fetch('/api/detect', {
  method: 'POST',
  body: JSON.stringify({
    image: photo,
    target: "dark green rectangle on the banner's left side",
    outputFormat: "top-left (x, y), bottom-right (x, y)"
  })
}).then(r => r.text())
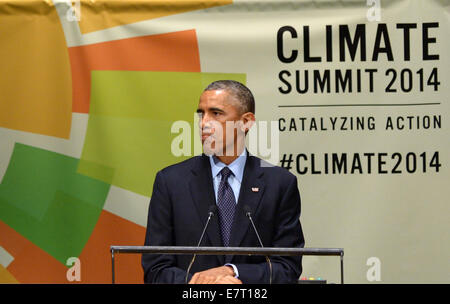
top-left (0, 143), bottom-right (110, 264)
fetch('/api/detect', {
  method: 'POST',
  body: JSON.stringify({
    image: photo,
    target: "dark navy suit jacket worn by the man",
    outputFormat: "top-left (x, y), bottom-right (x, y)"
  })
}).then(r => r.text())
top-left (142, 155), bottom-right (304, 283)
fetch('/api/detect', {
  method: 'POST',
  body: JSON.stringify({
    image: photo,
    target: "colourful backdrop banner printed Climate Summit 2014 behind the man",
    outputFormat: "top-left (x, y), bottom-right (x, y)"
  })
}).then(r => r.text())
top-left (0, 0), bottom-right (450, 283)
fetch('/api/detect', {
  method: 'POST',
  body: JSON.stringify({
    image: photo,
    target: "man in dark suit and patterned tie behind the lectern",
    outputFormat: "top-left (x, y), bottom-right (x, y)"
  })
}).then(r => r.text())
top-left (142, 80), bottom-right (304, 284)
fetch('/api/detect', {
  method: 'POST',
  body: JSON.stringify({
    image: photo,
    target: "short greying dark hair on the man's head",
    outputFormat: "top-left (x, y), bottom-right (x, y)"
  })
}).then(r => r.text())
top-left (204, 80), bottom-right (255, 114)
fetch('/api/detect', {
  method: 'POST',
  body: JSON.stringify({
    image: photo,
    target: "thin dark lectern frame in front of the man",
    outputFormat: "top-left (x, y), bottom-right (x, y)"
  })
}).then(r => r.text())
top-left (110, 246), bottom-right (344, 284)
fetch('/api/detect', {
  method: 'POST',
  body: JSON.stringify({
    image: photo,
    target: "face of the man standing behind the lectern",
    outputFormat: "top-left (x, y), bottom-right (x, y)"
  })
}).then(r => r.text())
top-left (197, 90), bottom-right (245, 156)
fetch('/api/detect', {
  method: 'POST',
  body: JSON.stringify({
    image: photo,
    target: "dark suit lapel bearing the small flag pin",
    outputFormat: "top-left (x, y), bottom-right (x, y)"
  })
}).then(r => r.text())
top-left (227, 155), bottom-right (265, 252)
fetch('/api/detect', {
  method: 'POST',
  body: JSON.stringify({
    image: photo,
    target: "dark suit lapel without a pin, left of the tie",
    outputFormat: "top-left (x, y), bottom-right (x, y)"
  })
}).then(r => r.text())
top-left (189, 155), bottom-right (224, 264)
